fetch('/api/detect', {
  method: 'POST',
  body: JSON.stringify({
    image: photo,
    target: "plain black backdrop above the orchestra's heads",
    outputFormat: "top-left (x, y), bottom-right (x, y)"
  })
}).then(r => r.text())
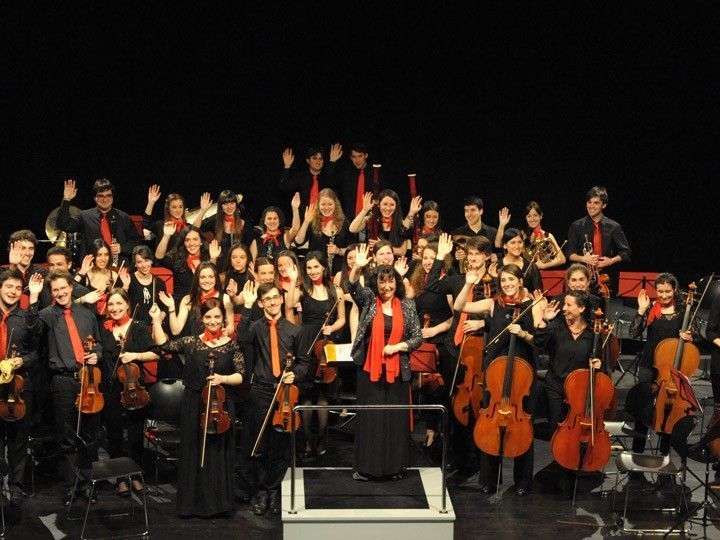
top-left (0, 2), bottom-right (720, 283)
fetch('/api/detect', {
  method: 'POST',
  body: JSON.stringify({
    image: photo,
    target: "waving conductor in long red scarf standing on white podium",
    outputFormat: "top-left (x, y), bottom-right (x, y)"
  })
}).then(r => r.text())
top-left (350, 245), bottom-right (422, 480)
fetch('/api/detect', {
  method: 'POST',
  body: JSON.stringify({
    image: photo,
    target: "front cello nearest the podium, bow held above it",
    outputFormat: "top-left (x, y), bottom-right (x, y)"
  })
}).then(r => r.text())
top-left (473, 307), bottom-right (534, 458)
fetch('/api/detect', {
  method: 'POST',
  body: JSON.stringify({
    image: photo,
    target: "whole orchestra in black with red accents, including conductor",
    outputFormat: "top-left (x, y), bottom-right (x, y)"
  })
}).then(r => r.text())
top-left (0, 143), bottom-right (720, 516)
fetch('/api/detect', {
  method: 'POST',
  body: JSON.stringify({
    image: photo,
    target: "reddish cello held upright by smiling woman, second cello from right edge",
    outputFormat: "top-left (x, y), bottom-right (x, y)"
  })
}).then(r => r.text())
top-left (550, 309), bottom-right (615, 471)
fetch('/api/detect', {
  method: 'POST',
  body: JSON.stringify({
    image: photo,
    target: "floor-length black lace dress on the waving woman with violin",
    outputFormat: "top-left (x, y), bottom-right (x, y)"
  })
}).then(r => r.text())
top-left (162, 336), bottom-right (245, 516)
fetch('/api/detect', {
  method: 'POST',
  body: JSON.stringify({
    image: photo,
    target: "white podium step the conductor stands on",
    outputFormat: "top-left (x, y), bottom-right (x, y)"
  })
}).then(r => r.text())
top-left (282, 468), bottom-right (455, 540)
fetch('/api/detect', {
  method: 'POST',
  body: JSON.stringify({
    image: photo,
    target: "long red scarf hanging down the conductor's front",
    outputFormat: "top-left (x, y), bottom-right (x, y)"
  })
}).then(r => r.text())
top-left (363, 296), bottom-right (404, 383)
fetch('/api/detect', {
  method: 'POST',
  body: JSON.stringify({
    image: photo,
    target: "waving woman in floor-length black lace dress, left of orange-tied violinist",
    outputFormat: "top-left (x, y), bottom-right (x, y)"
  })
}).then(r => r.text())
top-left (150, 298), bottom-right (245, 517)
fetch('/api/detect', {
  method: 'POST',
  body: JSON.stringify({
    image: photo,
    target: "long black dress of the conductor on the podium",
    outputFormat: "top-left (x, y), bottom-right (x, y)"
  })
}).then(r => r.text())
top-left (354, 314), bottom-right (410, 477)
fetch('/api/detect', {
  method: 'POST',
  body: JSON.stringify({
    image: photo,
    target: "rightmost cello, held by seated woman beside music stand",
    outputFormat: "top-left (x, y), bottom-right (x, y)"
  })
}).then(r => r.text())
top-left (652, 283), bottom-right (700, 435)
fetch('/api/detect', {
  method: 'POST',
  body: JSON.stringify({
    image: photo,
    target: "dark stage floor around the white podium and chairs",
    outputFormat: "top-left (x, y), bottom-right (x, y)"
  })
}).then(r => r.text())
top-left (5, 364), bottom-right (720, 540)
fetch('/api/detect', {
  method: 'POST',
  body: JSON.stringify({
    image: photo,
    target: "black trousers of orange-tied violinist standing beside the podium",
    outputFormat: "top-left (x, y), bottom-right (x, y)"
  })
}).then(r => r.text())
top-left (238, 384), bottom-right (297, 496)
